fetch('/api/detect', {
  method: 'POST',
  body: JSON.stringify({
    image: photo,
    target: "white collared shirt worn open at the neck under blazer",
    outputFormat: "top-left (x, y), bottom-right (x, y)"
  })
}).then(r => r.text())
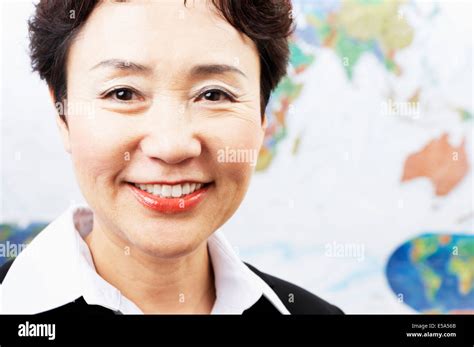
top-left (0, 205), bottom-right (289, 314)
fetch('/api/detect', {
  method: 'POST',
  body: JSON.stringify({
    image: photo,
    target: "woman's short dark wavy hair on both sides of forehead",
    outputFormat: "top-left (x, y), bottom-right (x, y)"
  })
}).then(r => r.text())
top-left (28, 0), bottom-right (294, 117)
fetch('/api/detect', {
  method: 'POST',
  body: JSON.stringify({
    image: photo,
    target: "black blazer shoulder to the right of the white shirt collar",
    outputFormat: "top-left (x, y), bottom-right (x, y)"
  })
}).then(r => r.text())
top-left (245, 263), bottom-right (344, 314)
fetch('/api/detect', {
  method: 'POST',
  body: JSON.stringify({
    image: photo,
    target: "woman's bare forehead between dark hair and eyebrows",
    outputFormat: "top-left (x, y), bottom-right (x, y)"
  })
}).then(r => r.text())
top-left (70, 0), bottom-right (258, 78)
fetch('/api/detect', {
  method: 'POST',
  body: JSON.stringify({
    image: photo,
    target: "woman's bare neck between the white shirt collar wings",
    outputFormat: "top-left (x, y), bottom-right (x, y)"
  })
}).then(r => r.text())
top-left (86, 220), bottom-right (215, 314)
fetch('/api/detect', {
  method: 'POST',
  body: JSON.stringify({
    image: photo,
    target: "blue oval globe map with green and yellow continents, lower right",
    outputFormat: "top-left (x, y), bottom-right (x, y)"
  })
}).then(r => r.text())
top-left (387, 234), bottom-right (474, 314)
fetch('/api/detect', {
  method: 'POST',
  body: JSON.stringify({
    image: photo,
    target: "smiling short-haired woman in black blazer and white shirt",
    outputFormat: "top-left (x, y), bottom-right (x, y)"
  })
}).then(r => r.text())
top-left (2, 0), bottom-right (342, 314)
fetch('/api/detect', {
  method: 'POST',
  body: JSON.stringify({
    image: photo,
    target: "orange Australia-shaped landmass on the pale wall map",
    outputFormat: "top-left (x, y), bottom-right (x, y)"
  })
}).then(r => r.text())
top-left (402, 134), bottom-right (469, 195)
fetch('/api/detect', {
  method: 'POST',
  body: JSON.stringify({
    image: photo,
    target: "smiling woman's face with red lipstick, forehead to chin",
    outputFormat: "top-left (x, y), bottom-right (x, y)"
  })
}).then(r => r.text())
top-left (59, 0), bottom-right (265, 257)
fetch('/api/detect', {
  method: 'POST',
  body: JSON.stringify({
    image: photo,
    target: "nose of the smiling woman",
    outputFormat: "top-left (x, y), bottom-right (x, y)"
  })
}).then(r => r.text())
top-left (140, 101), bottom-right (201, 164)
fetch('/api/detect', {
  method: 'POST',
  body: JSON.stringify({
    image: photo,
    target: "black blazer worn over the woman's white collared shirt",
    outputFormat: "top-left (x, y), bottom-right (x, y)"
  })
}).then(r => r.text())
top-left (0, 260), bottom-right (344, 315)
